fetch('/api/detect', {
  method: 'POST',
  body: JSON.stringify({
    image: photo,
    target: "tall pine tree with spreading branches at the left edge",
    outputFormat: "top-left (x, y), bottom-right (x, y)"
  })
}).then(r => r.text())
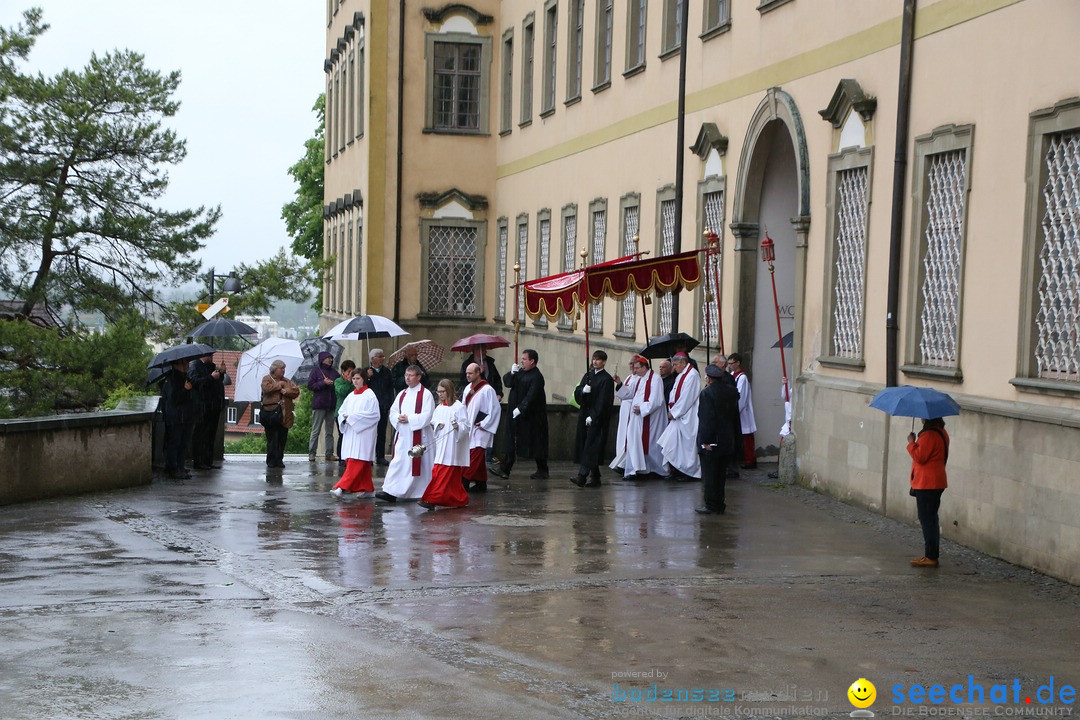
top-left (0, 9), bottom-right (220, 320)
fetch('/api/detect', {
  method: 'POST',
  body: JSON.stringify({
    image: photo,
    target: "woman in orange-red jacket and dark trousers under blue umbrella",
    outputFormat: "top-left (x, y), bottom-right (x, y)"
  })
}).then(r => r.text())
top-left (907, 418), bottom-right (948, 568)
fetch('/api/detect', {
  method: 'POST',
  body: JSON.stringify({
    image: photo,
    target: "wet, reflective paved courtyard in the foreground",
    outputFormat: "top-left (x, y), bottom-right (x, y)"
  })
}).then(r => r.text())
top-left (0, 457), bottom-right (1080, 718)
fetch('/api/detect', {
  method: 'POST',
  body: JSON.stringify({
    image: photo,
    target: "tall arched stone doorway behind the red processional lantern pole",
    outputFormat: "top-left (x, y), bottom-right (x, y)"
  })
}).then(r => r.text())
top-left (731, 87), bottom-right (810, 457)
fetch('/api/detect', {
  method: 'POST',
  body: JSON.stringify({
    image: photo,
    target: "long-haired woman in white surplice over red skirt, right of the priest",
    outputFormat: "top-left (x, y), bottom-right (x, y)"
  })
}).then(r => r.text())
top-left (419, 379), bottom-right (469, 510)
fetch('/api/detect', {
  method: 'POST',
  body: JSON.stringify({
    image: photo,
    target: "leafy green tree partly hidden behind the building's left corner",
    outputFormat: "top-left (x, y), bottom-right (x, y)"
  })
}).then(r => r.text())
top-left (281, 95), bottom-right (327, 310)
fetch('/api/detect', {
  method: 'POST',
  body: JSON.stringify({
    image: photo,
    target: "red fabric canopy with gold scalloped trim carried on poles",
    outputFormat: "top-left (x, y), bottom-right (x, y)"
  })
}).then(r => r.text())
top-left (525, 250), bottom-right (702, 318)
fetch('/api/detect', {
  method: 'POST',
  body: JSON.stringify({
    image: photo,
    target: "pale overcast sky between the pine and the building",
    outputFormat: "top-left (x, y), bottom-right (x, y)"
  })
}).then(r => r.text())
top-left (0, 0), bottom-right (326, 280)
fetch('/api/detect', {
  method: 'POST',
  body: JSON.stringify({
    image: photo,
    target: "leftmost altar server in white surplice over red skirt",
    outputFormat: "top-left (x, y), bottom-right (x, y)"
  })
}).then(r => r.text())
top-left (330, 372), bottom-right (379, 498)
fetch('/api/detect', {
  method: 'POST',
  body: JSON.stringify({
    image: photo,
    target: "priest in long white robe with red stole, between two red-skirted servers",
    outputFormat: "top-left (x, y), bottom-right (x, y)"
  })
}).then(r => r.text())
top-left (375, 365), bottom-right (435, 502)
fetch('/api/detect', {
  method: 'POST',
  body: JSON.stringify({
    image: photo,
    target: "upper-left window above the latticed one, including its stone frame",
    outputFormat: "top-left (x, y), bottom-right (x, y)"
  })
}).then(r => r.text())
top-left (424, 27), bottom-right (491, 134)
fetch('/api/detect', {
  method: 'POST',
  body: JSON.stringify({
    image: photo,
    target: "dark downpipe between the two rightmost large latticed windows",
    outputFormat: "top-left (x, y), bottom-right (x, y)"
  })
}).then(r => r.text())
top-left (885, 0), bottom-right (916, 388)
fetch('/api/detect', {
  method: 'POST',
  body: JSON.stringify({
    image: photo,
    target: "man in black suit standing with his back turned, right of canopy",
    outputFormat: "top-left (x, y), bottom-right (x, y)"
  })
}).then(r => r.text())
top-left (697, 364), bottom-right (739, 515)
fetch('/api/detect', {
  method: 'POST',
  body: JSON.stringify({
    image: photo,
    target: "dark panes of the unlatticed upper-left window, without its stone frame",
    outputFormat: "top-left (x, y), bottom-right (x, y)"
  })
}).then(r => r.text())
top-left (434, 42), bottom-right (482, 130)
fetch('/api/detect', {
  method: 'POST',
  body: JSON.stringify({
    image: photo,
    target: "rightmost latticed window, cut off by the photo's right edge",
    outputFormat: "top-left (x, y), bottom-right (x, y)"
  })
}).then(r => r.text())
top-left (1034, 132), bottom-right (1080, 382)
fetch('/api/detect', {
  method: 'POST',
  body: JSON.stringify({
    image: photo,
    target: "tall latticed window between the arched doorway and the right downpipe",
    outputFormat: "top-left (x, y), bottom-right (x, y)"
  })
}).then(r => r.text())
top-left (822, 148), bottom-right (873, 367)
